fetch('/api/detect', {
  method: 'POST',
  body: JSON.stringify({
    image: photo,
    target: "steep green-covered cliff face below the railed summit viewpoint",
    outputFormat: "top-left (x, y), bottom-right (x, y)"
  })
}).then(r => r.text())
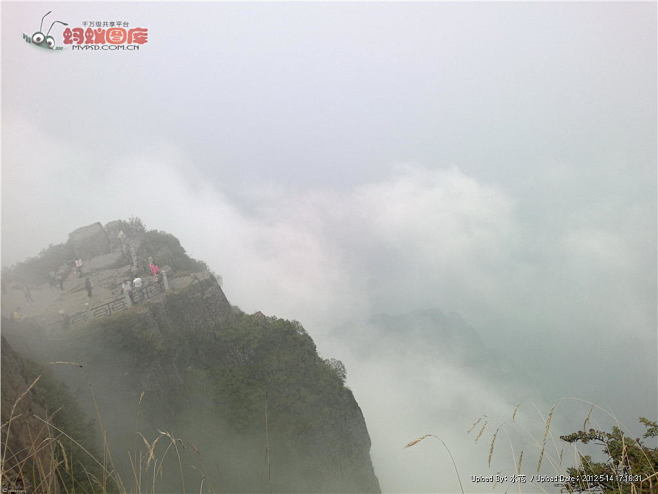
top-left (3, 221), bottom-right (379, 492)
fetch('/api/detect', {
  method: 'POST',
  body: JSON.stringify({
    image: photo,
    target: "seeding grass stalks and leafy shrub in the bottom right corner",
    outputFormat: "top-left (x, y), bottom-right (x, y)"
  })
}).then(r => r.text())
top-left (405, 397), bottom-right (658, 494)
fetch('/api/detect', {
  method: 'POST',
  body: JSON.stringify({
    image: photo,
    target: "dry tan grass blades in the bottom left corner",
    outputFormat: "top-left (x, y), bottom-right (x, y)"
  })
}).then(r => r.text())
top-left (0, 377), bottom-right (215, 494)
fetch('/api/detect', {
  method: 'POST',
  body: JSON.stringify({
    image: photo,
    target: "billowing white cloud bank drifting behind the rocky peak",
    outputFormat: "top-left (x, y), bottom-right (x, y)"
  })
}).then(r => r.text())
top-left (3, 120), bottom-right (650, 490)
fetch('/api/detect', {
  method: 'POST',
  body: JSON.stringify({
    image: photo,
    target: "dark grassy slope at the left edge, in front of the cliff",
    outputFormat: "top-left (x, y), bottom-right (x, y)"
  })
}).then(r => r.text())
top-left (0, 330), bottom-right (99, 492)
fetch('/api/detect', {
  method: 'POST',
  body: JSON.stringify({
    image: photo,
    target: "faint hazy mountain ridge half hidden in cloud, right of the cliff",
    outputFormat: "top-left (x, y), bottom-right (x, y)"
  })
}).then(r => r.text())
top-left (330, 308), bottom-right (539, 418)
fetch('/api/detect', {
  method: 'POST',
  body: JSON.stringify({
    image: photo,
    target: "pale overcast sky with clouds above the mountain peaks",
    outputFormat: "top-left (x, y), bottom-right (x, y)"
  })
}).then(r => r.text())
top-left (2, 2), bottom-right (658, 490)
